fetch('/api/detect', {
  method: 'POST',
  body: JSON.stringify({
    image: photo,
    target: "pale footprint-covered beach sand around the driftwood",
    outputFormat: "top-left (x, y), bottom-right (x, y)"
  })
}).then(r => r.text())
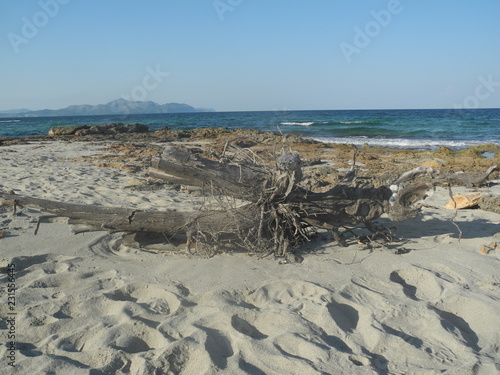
top-left (0, 143), bottom-right (500, 375)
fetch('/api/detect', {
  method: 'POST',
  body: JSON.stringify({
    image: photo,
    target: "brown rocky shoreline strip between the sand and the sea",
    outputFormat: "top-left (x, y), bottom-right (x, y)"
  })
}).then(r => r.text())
top-left (0, 123), bottom-right (500, 187)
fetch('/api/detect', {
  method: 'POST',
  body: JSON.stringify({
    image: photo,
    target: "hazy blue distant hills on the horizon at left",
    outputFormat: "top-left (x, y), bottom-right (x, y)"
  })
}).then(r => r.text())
top-left (0, 99), bottom-right (214, 117)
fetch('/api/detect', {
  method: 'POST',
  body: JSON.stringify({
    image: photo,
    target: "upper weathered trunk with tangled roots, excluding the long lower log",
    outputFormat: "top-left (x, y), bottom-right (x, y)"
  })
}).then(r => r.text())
top-left (151, 148), bottom-right (436, 254)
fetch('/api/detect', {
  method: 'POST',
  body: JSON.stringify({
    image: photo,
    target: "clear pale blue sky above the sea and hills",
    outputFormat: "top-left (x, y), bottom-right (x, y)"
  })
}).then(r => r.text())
top-left (0, 0), bottom-right (500, 111)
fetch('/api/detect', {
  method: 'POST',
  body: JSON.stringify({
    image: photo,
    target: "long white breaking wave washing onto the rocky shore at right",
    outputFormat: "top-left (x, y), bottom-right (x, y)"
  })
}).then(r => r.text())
top-left (307, 136), bottom-right (500, 150)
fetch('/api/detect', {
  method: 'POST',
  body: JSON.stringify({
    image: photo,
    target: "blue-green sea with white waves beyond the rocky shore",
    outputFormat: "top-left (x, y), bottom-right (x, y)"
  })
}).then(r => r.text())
top-left (0, 108), bottom-right (500, 149)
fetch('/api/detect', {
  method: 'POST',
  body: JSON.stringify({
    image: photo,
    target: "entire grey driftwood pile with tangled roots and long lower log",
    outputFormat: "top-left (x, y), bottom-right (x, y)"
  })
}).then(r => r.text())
top-left (0, 147), bottom-right (440, 256)
